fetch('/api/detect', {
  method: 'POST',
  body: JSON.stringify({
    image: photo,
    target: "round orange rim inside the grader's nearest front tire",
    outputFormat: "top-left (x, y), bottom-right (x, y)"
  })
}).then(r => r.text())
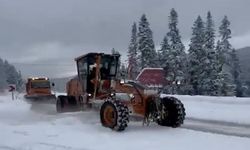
top-left (103, 106), bottom-right (116, 127)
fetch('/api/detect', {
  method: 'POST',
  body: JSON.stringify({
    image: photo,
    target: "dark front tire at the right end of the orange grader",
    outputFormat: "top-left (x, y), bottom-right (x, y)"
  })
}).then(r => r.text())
top-left (157, 97), bottom-right (186, 128)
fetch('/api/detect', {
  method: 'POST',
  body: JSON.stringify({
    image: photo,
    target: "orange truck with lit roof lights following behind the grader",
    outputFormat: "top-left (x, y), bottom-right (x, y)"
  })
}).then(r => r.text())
top-left (24, 77), bottom-right (56, 103)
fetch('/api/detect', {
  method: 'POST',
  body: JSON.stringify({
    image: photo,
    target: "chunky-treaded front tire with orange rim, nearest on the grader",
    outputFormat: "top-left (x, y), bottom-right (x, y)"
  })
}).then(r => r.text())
top-left (100, 101), bottom-right (129, 131)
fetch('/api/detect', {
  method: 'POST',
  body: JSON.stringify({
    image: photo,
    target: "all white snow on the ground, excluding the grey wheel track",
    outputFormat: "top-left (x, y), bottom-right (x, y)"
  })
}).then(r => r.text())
top-left (0, 94), bottom-right (250, 150)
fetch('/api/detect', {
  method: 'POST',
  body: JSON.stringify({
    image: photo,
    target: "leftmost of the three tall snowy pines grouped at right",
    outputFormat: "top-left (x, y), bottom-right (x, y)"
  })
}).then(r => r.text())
top-left (188, 16), bottom-right (207, 95)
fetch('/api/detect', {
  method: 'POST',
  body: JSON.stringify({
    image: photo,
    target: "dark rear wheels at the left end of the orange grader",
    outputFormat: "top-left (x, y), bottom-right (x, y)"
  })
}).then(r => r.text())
top-left (56, 95), bottom-right (83, 113)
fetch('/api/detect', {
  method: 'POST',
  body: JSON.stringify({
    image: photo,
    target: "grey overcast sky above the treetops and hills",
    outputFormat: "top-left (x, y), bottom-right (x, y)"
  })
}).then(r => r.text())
top-left (0, 0), bottom-right (250, 77)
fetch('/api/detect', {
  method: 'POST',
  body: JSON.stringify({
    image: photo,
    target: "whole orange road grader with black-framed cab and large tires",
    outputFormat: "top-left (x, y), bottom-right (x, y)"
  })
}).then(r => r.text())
top-left (56, 53), bottom-right (185, 131)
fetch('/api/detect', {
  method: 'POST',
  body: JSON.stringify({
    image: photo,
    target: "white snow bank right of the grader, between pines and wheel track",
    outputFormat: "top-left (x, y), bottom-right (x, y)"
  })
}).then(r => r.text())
top-left (172, 95), bottom-right (250, 124)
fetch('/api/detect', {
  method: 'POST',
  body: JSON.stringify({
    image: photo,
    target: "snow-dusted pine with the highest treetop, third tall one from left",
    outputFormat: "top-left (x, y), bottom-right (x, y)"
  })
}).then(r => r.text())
top-left (165, 8), bottom-right (187, 94)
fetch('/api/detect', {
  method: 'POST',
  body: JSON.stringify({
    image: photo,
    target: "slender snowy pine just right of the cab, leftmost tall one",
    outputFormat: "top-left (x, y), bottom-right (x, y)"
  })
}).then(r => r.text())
top-left (128, 23), bottom-right (140, 80)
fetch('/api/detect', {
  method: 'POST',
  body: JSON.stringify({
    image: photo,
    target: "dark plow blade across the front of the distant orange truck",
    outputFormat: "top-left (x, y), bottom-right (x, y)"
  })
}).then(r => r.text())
top-left (24, 95), bottom-right (56, 104)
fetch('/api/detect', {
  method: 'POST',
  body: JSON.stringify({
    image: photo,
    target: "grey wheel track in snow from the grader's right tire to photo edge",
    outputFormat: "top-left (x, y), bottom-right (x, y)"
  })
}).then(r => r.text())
top-left (182, 118), bottom-right (250, 138)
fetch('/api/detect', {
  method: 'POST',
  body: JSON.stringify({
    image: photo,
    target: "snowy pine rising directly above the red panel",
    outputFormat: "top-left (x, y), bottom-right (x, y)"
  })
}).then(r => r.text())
top-left (138, 14), bottom-right (157, 69)
